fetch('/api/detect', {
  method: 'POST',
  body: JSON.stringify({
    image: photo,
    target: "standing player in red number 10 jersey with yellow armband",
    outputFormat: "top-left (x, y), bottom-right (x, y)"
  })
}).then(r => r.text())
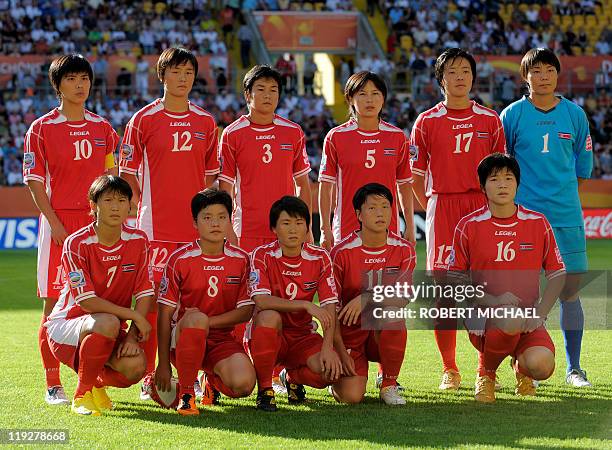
top-left (23, 54), bottom-right (119, 405)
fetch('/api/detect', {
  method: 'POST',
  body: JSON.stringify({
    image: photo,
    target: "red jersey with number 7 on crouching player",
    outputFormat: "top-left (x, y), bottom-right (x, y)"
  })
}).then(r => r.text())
top-left (49, 223), bottom-right (155, 320)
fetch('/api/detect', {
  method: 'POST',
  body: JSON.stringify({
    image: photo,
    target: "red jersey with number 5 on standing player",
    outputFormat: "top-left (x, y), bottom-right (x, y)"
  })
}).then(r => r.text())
top-left (319, 119), bottom-right (412, 242)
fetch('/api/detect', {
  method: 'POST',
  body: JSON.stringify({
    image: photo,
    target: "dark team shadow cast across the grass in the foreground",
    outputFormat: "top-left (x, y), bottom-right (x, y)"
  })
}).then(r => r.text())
top-left (125, 389), bottom-right (612, 449)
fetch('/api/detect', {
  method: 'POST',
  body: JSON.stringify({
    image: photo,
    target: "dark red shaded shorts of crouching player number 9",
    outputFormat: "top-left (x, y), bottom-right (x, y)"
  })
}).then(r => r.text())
top-left (245, 329), bottom-right (323, 369)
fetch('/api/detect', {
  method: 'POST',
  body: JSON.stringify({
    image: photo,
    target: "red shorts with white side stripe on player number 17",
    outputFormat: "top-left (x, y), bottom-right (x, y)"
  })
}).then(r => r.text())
top-left (425, 191), bottom-right (487, 270)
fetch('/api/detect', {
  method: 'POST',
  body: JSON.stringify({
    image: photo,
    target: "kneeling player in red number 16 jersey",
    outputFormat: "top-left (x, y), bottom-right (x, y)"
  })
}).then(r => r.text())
top-left (449, 154), bottom-right (565, 403)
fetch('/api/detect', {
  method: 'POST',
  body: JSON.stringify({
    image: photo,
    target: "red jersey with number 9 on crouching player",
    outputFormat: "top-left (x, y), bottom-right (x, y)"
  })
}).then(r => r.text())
top-left (249, 241), bottom-right (338, 330)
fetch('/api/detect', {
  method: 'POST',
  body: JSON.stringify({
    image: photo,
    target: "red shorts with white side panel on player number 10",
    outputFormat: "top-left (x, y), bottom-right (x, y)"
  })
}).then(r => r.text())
top-left (36, 210), bottom-right (93, 300)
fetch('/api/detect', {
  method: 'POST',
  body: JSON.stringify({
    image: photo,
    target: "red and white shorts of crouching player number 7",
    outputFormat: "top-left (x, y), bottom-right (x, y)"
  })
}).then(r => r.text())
top-left (45, 314), bottom-right (127, 372)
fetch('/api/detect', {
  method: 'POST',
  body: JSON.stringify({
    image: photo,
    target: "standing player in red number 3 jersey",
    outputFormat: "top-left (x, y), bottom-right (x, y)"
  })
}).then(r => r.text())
top-left (219, 65), bottom-right (311, 252)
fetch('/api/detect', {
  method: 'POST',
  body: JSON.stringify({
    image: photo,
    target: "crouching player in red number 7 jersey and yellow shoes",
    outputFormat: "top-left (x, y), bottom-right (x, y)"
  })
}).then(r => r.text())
top-left (45, 175), bottom-right (154, 416)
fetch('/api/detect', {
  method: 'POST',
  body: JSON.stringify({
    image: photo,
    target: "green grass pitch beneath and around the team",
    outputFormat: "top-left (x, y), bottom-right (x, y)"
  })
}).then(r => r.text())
top-left (0, 241), bottom-right (612, 449)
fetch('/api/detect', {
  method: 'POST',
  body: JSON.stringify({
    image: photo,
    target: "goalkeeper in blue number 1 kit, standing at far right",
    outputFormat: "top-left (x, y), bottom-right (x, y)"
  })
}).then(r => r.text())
top-left (502, 48), bottom-right (593, 387)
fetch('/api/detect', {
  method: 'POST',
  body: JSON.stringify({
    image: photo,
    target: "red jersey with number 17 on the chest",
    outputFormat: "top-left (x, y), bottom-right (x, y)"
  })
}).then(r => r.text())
top-left (410, 101), bottom-right (506, 197)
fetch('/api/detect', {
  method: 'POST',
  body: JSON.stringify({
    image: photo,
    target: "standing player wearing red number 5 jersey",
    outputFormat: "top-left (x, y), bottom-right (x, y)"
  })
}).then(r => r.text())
top-left (319, 71), bottom-right (414, 250)
